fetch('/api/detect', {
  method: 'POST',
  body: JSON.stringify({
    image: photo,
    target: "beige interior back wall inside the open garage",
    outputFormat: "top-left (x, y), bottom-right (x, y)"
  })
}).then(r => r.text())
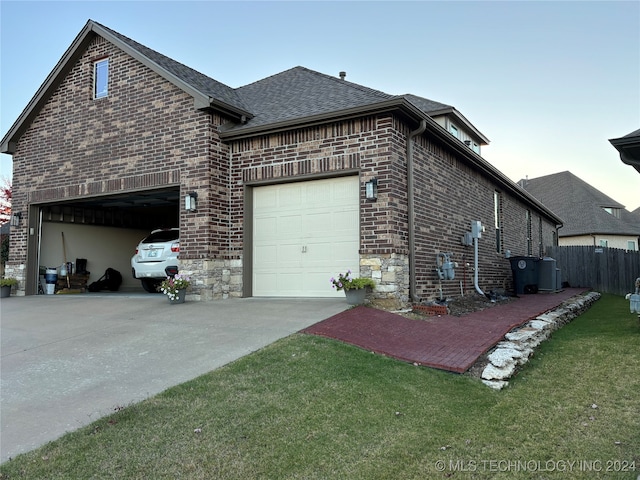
top-left (40, 222), bottom-right (149, 292)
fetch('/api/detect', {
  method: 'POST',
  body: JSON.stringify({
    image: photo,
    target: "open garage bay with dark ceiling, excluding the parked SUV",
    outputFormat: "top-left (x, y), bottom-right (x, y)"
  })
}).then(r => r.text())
top-left (27, 186), bottom-right (180, 294)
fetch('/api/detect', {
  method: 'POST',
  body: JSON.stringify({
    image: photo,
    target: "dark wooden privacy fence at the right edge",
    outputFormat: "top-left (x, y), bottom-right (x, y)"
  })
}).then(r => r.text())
top-left (546, 246), bottom-right (640, 295)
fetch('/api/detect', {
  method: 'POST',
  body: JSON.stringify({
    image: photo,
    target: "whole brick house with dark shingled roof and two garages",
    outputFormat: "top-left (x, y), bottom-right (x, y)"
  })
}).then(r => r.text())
top-left (1, 21), bottom-right (561, 304)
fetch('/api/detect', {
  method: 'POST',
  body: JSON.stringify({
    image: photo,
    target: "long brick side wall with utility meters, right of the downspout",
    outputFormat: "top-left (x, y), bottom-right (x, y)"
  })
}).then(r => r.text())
top-left (414, 127), bottom-right (555, 298)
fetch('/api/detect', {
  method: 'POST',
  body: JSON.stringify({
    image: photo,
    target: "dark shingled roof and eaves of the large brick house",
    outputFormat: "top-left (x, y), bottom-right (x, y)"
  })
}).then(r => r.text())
top-left (0, 20), bottom-right (561, 224)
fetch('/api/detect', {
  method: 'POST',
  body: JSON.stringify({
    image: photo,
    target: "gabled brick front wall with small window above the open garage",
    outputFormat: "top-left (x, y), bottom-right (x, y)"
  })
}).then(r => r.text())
top-left (10, 37), bottom-right (229, 296)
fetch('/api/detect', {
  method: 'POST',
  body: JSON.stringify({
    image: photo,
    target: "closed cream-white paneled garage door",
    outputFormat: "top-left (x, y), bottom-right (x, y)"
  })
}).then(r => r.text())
top-left (253, 177), bottom-right (360, 297)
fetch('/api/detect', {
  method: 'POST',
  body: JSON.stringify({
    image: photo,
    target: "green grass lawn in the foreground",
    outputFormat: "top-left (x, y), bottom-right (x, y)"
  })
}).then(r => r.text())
top-left (0, 295), bottom-right (640, 480)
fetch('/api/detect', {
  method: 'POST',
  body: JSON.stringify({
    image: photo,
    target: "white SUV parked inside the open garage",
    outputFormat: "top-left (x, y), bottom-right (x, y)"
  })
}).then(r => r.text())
top-left (131, 228), bottom-right (180, 293)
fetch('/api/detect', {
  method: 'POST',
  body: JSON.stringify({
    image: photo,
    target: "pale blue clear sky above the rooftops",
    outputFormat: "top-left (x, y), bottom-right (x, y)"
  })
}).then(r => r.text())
top-left (0, 0), bottom-right (640, 210)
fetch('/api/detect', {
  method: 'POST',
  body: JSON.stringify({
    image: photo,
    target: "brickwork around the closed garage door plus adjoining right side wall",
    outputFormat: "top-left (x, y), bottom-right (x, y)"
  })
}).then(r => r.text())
top-left (230, 115), bottom-right (554, 303)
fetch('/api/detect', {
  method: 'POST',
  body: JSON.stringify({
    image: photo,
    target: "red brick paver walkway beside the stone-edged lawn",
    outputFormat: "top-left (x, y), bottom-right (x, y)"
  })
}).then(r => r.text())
top-left (303, 288), bottom-right (585, 373)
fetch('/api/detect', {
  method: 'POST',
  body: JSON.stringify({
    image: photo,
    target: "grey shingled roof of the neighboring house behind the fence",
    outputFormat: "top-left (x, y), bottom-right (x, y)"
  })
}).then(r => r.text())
top-left (518, 172), bottom-right (640, 237)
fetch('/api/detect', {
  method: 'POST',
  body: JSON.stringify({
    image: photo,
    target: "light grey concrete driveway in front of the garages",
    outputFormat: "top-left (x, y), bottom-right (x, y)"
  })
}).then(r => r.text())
top-left (0, 293), bottom-right (348, 462)
